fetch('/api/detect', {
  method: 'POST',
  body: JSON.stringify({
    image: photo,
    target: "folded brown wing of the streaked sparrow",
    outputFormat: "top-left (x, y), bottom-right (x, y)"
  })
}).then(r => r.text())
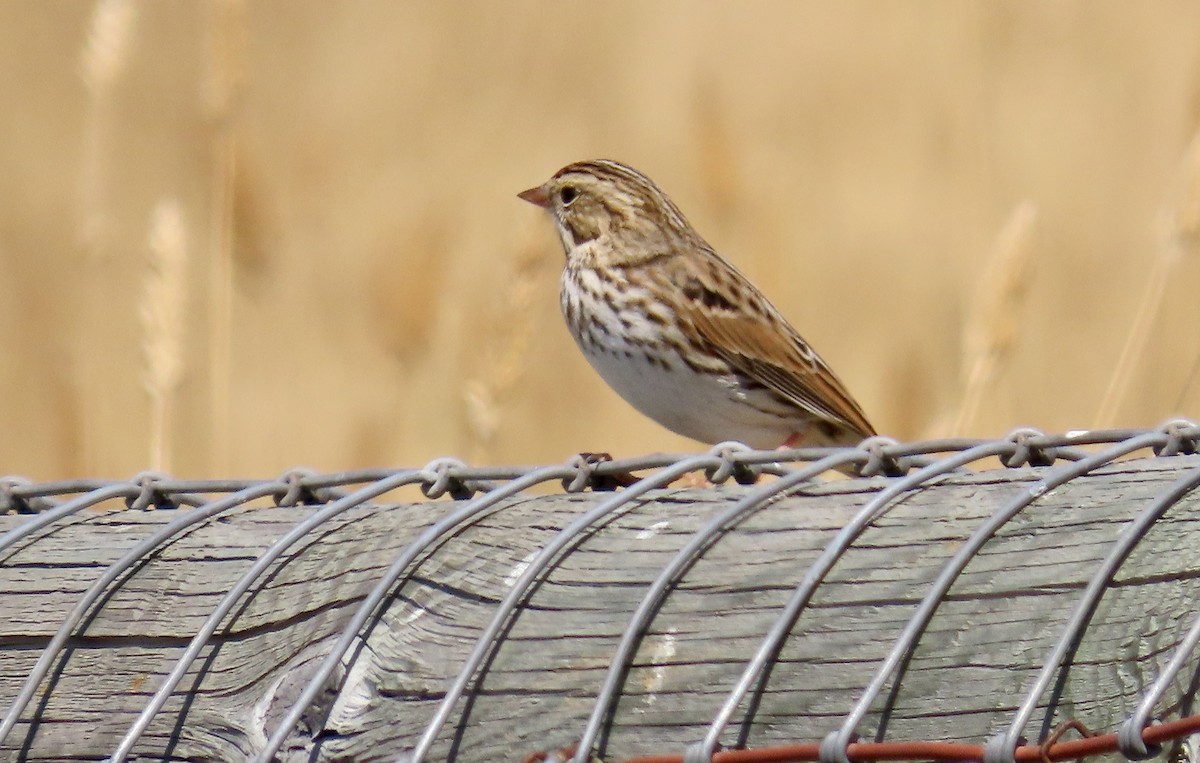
top-left (677, 260), bottom-right (875, 438)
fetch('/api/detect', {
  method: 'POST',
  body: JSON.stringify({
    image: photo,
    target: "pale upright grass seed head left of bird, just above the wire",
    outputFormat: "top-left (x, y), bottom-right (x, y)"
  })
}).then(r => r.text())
top-left (138, 199), bottom-right (187, 471)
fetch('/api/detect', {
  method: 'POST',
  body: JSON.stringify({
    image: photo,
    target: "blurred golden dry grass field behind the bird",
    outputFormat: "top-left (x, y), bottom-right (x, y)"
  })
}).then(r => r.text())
top-left (0, 0), bottom-right (1200, 479)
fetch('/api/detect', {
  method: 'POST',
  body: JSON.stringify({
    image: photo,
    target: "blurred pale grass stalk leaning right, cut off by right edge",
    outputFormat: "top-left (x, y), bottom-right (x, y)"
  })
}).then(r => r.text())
top-left (1096, 131), bottom-right (1200, 428)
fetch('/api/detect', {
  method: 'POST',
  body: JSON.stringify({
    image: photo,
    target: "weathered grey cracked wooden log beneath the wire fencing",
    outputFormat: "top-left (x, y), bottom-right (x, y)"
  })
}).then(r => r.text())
top-left (0, 457), bottom-right (1200, 762)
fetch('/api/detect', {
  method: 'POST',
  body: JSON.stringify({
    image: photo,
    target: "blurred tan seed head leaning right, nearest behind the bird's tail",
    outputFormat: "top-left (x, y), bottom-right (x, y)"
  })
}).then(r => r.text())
top-left (954, 202), bottom-right (1038, 434)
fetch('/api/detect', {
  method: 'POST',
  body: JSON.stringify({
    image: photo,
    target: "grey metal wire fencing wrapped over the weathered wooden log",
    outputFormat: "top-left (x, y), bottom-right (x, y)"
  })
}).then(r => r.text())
top-left (0, 421), bottom-right (1200, 763)
